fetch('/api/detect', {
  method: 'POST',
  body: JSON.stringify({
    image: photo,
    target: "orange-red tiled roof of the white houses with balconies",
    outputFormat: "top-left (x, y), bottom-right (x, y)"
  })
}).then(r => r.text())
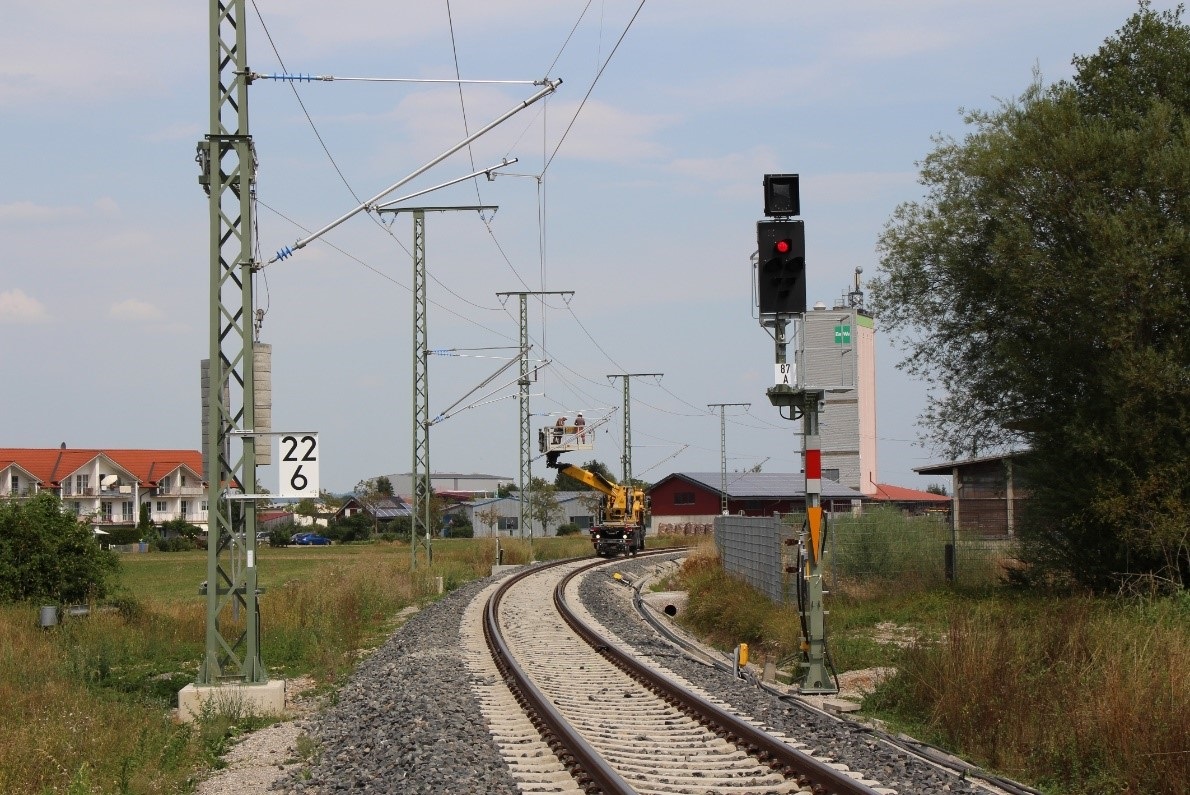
top-left (0, 447), bottom-right (206, 486)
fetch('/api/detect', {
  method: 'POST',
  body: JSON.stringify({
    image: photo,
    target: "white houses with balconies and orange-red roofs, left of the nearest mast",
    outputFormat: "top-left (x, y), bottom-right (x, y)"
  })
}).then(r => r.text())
top-left (0, 443), bottom-right (208, 532)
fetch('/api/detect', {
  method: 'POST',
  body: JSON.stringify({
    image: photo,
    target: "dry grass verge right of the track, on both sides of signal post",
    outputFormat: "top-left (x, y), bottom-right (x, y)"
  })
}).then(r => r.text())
top-left (679, 546), bottom-right (1190, 795)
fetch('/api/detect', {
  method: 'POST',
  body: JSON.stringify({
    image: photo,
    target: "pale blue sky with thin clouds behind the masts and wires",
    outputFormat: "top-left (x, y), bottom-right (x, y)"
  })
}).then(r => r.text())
top-left (0, 0), bottom-right (1173, 490)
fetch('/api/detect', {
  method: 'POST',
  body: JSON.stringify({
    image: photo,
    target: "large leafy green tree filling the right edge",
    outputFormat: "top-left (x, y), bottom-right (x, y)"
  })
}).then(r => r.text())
top-left (871, 2), bottom-right (1190, 588)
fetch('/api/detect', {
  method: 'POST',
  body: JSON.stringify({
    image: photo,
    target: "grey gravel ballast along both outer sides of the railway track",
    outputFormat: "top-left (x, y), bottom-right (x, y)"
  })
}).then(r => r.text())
top-left (273, 558), bottom-right (1018, 795)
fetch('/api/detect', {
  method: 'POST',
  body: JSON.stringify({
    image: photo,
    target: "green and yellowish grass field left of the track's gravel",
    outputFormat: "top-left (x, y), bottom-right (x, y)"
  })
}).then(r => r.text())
top-left (0, 537), bottom-right (590, 795)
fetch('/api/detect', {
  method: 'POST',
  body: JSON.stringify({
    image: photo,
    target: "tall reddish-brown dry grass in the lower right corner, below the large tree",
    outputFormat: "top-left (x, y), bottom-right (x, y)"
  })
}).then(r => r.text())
top-left (876, 597), bottom-right (1190, 795)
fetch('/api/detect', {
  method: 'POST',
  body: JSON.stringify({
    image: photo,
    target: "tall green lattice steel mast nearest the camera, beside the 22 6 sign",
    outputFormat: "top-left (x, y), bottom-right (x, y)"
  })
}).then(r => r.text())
top-left (196, 0), bottom-right (268, 684)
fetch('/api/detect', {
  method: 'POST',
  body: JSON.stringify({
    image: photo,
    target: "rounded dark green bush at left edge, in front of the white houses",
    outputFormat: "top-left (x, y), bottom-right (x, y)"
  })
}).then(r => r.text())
top-left (0, 492), bottom-right (119, 602)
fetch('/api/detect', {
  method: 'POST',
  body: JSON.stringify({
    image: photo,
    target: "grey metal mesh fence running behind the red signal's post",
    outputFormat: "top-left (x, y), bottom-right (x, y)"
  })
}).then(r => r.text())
top-left (715, 508), bottom-right (1017, 602)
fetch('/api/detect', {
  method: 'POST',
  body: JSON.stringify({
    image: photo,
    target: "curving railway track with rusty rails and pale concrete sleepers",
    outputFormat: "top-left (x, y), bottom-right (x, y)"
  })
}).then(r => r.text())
top-left (463, 552), bottom-right (894, 795)
